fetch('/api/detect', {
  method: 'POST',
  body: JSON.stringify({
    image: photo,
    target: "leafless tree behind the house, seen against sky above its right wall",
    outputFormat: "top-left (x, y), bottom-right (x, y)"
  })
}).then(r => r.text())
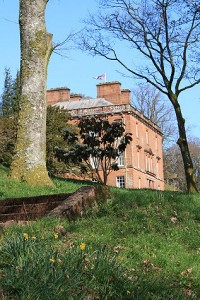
top-left (132, 84), bottom-right (177, 148)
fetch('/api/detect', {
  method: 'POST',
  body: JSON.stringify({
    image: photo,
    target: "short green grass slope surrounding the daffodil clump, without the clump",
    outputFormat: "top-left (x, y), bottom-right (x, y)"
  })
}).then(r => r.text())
top-left (1, 165), bottom-right (200, 300)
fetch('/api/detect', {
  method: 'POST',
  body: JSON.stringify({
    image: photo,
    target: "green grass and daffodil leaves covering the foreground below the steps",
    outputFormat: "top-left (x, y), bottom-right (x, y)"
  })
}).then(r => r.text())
top-left (0, 165), bottom-right (200, 300)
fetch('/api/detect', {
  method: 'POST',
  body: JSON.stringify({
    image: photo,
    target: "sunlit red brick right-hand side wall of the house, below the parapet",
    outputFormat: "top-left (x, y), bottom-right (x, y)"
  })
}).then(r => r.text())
top-left (104, 114), bottom-right (164, 190)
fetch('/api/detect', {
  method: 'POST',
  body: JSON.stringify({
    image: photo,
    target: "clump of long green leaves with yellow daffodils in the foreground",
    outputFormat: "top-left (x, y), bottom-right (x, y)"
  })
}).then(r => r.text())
top-left (0, 228), bottom-right (131, 300)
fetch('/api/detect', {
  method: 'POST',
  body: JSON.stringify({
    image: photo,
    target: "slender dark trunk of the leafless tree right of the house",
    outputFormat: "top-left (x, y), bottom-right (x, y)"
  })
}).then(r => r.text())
top-left (169, 93), bottom-right (198, 193)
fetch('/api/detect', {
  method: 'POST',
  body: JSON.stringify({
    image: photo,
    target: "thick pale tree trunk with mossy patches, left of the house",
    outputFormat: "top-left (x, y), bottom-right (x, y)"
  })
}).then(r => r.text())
top-left (10, 0), bottom-right (53, 185)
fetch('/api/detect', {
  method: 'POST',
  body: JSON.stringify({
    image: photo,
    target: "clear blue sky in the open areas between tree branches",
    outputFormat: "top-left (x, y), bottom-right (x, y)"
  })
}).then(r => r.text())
top-left (0, 0), bottom-right (200, 138)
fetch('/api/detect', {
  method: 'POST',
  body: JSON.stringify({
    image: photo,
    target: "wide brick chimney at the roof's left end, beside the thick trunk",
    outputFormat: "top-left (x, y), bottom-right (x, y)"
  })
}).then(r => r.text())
top-left (47, 88), bottom-right (70, 105)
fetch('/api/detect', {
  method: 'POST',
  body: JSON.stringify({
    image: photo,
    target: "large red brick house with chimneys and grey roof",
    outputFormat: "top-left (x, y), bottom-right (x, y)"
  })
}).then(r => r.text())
top-left (47, 81), bottom-right (164, 190)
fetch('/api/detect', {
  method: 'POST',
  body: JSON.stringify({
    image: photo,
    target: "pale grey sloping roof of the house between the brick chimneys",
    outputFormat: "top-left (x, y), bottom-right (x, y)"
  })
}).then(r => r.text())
top-left (54, 98), bottom-right (113, 110)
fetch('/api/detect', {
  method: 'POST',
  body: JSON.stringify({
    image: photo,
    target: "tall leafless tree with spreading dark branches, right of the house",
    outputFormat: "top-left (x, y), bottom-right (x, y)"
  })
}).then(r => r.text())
top-left (81, 0), bottom-right (200, 192)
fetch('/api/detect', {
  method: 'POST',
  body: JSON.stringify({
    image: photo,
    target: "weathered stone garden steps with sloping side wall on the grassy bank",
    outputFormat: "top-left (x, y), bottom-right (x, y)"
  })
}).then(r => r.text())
top-left (0, 185), bottom-right (101, 224)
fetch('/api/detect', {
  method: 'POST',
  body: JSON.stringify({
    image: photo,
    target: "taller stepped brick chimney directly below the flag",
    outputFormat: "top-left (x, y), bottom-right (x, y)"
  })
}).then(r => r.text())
top-left (97, 81), bottom-right (130, 104)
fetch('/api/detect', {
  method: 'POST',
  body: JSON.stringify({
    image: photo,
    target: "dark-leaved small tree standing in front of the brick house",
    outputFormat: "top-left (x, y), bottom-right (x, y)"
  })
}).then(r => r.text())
top-left (57, 117), bottom-right (132, 184)
